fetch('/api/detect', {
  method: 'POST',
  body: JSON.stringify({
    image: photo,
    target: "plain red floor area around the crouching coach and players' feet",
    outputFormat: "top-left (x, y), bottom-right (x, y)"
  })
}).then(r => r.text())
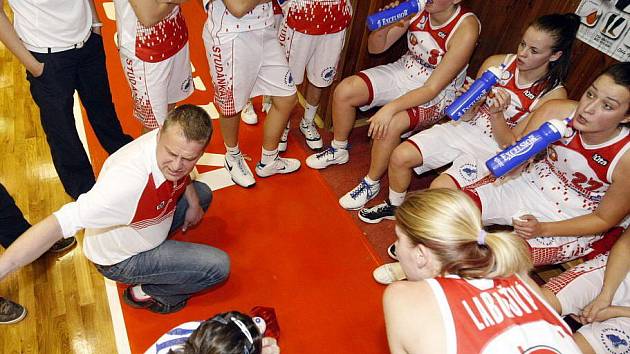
top-left (86, 2), bottom-right (387, 354)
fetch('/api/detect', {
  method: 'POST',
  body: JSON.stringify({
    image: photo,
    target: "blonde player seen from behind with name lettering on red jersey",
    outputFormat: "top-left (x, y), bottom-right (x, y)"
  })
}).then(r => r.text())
top-left (375, 189), bottom-right (580, 354)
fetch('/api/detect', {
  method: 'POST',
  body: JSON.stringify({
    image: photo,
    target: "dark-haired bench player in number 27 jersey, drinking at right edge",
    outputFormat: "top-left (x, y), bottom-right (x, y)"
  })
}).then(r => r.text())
top-left (467, 62), bottom-right (630, 265)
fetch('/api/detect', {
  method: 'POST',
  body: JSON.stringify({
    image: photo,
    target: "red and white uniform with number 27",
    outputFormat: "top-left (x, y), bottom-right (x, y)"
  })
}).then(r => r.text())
top-left (475, 127), bottom-right (630, 265)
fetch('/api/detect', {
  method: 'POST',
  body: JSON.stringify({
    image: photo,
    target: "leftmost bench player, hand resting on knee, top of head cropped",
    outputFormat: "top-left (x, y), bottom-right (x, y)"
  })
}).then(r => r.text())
top-left (306, 0), bottom-right (480, 209)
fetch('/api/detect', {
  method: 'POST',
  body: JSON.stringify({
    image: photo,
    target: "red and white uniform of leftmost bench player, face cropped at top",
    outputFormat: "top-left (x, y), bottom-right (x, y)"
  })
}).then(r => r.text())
top-left (357, 6), bottom-right (481, 129)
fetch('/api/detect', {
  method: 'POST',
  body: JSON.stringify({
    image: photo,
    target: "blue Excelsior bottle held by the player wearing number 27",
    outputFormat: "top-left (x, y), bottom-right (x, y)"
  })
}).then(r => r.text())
top-left (486, 118), bottom-right (571, 177)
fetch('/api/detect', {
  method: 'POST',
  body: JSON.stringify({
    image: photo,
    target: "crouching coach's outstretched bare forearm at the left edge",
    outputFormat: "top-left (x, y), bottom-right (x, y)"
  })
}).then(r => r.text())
top-left (0, 215), bottom-right (62, 279)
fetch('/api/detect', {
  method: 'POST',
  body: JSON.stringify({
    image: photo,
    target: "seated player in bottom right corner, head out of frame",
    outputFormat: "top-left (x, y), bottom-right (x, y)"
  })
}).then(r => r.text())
top-left (542, 225), bottom-right (630, 354)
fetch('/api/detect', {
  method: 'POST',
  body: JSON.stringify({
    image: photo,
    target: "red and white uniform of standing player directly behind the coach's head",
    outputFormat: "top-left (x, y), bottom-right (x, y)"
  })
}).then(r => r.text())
top-left (114, 0), bottom-right (194, 129)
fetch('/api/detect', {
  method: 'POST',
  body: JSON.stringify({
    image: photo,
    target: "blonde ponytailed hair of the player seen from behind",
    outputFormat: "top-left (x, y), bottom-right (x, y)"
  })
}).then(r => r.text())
top-left (396, 189), bottom-right (532, 278)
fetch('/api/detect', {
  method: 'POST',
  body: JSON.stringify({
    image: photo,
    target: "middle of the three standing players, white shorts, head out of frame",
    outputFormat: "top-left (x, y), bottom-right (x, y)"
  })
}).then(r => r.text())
top-left (203, 0), bottom-right (300, 188)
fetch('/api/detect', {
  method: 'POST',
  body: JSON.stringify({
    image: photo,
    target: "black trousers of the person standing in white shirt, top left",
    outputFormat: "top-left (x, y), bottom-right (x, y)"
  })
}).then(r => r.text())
top-left (26, 34), bottom-right (132, 199)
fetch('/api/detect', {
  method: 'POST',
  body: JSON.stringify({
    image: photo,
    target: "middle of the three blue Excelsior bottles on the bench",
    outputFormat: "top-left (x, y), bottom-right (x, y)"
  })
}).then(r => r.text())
top-left (444, 64), bottom-right (505, 120)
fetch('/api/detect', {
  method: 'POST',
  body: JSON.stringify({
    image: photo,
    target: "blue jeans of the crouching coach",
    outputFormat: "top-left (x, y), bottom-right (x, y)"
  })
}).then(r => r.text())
top-left (96, 182), bottom-right (230, 306)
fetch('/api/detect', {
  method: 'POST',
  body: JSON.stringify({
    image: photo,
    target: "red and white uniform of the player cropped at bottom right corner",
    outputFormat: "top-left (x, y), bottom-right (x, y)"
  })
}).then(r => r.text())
top-left (545, 254), bottom-right (630, 354)
